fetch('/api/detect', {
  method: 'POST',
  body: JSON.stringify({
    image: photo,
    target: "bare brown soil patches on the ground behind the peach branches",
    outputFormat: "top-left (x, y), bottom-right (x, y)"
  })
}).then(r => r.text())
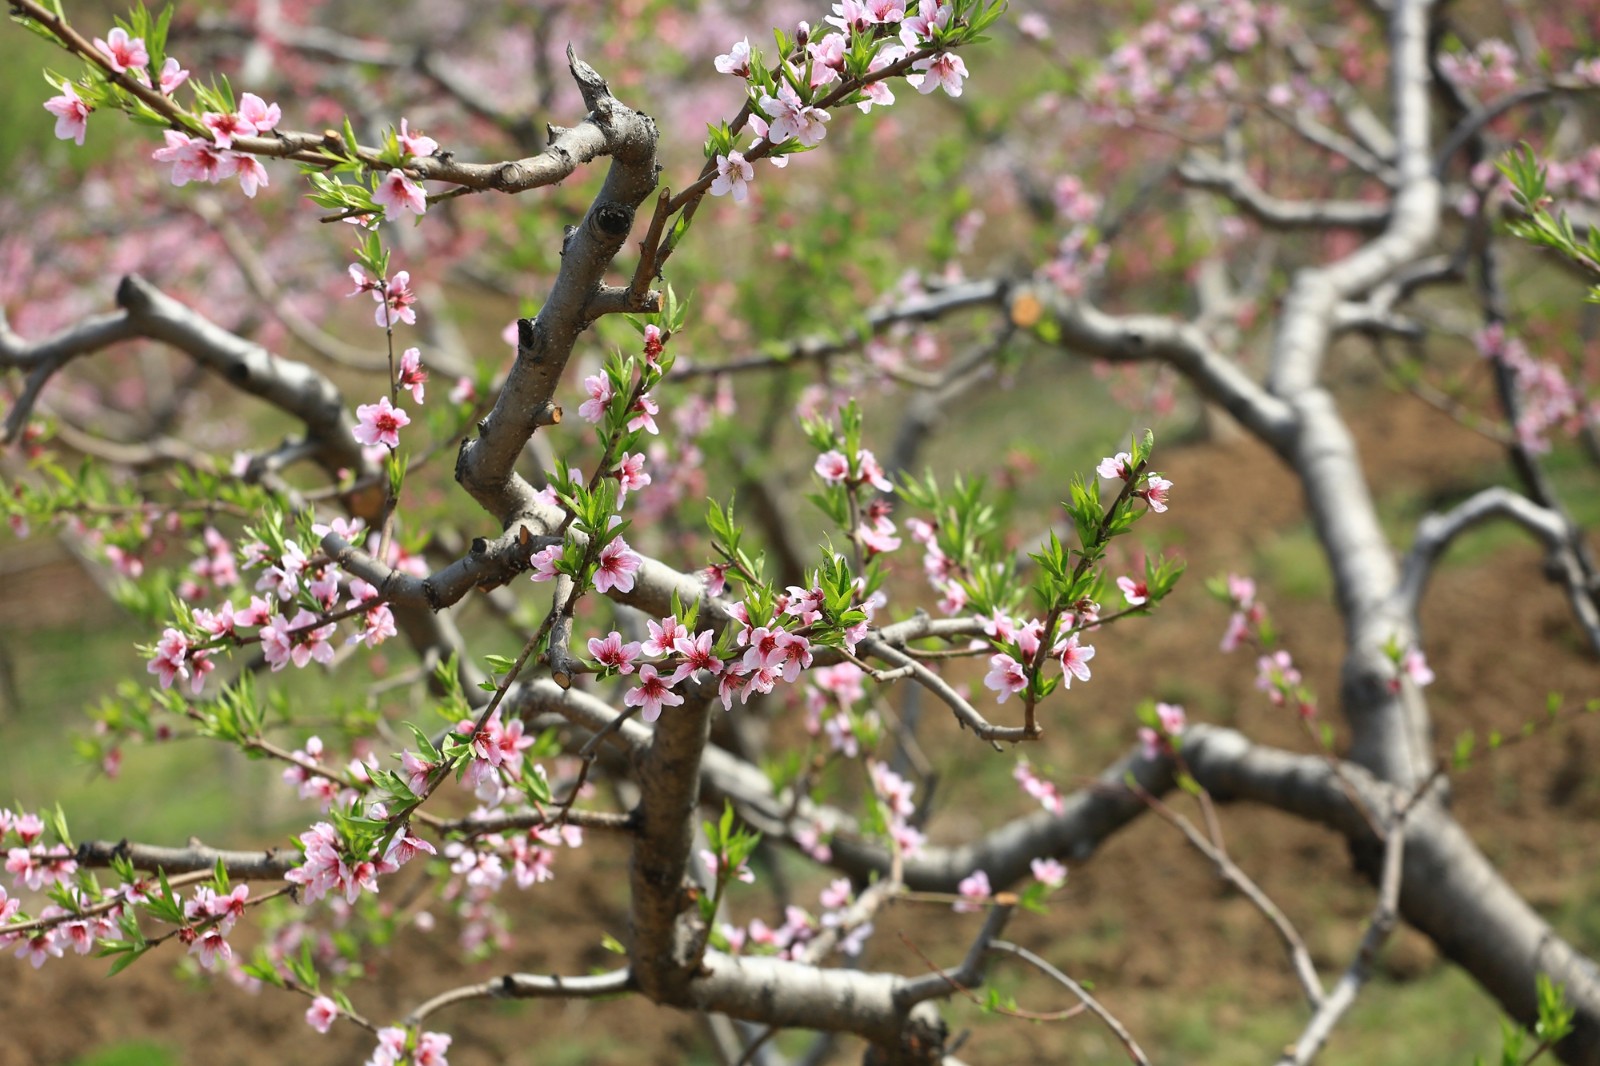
top-left (0, 384), bottom-right (1600, 1066)
